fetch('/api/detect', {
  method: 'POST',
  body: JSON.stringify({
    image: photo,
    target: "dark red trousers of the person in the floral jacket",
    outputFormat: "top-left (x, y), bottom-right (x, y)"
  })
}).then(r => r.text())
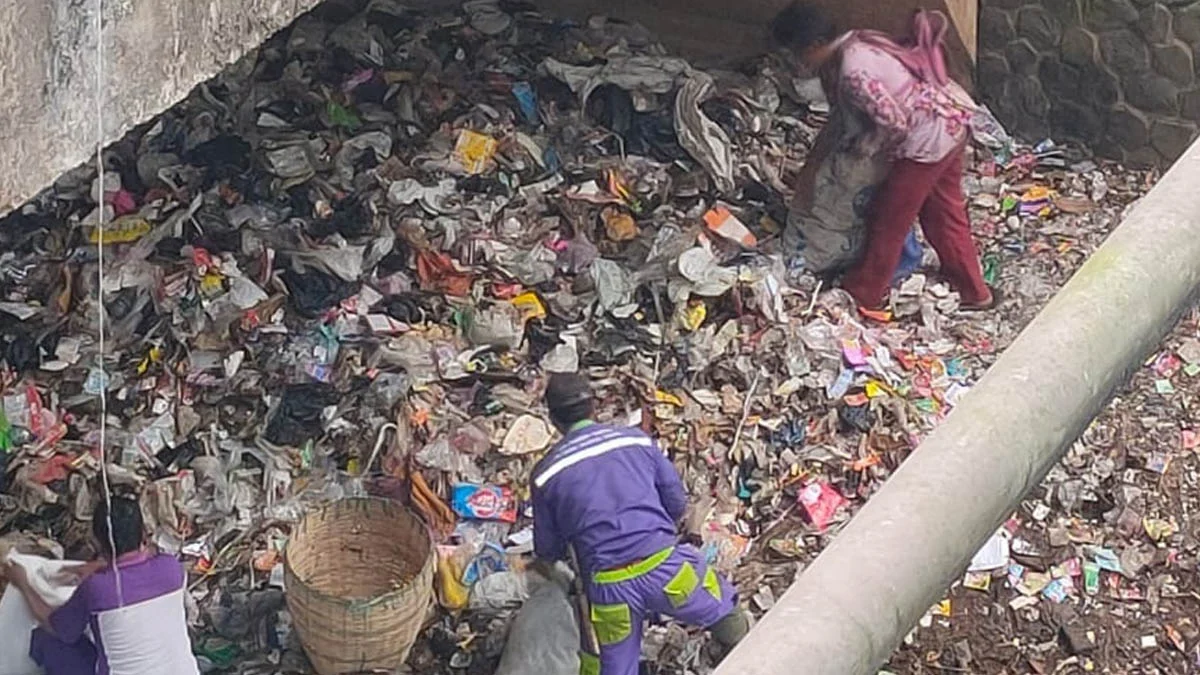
top-left (841, 148), bottom-right (990, 309)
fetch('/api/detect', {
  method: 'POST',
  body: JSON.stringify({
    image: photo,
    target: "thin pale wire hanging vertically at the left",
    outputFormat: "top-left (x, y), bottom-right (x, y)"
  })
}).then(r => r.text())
top-left (95, 0), bottom-right (125, 608)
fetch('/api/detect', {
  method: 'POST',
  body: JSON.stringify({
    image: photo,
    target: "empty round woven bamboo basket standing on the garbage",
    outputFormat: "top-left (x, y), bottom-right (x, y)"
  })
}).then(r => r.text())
top-left (283, 497), bottom-right (437, 675)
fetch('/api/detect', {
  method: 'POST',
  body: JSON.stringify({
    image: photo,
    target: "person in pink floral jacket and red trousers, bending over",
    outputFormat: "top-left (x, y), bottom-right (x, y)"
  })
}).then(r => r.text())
top-left (770, 2), bottom-right (996, 310)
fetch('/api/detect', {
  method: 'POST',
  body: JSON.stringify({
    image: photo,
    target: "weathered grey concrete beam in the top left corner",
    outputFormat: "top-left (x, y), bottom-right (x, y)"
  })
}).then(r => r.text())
top-left (0, 0), bottom-right (318, 215)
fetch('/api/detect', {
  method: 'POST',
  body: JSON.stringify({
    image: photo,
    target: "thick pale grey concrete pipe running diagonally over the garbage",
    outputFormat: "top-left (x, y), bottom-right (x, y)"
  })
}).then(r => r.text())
top-left (715, 143), bottom-right (1200, 675)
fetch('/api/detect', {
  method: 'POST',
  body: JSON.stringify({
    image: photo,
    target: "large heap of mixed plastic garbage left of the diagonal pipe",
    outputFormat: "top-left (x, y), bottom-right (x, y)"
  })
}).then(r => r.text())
top-left (0, 0), bottom-right (1151, 673)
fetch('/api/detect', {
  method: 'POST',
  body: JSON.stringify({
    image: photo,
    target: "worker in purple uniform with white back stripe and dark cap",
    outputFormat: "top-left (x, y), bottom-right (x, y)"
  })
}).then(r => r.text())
top-left (533, 375), bottom-right (750, 675)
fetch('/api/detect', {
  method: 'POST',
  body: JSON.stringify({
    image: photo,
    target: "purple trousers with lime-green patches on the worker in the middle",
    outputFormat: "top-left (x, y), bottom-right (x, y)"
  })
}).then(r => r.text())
top-left (580, 544), bottom-right (738, 675)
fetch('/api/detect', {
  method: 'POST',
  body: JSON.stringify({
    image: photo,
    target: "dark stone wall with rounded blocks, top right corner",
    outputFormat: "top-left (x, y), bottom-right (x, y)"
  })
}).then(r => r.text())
top-left (978, 0), bottom-right (1200, 166)
